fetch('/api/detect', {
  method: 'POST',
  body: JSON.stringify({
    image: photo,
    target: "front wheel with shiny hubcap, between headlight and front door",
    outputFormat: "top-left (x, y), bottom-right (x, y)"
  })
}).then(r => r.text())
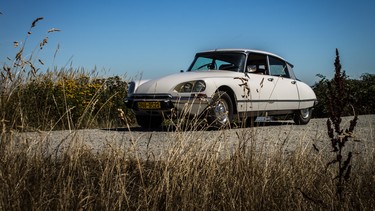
top-left (207, 91), bottom-right (233, 128)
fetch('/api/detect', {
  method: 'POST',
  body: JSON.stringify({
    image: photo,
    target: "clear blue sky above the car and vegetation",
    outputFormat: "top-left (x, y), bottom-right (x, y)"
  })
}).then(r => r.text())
top-left (0, 0), bottom-right (375, 85)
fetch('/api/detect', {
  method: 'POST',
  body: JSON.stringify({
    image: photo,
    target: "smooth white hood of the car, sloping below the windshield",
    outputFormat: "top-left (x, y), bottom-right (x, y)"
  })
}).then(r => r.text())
top-left (135, 70), bottom-right (234, 93)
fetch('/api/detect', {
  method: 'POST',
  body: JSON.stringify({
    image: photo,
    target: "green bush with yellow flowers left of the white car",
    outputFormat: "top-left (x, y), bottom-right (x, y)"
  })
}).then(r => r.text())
top-left (5, 69), bottom-right (131, 130)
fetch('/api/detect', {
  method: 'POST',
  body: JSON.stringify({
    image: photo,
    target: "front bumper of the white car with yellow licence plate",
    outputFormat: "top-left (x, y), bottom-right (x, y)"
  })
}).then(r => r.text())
top-left (125, 94), bottom-right (211, 115)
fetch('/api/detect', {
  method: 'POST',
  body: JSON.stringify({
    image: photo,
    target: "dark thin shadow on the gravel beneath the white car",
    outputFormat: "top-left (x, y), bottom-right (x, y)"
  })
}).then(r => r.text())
top-left (101, 121), bottom-right (295, 132)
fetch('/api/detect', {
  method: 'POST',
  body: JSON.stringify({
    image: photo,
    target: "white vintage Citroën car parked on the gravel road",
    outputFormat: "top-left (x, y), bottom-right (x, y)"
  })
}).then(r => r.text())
top-left (125, 49), bottom-right (317, 128)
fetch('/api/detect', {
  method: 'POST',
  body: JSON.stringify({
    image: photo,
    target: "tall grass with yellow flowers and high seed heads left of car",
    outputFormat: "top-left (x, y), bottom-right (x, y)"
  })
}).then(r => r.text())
top-left (0, 18), bottom-right (131, 130)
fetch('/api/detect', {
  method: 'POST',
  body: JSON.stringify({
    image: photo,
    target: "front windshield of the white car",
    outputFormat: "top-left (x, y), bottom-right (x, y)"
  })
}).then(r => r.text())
top-left (188, 52), bottom-right (246, 72)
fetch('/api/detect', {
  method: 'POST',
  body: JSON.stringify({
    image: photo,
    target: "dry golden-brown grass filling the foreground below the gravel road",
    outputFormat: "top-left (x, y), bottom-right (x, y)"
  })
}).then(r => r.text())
top-left (0, 126), bottom-right (375, 210)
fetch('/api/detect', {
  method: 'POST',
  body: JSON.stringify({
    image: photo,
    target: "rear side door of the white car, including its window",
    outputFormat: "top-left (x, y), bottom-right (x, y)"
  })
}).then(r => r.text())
top-left (268, 56), bottom-right (299, 110)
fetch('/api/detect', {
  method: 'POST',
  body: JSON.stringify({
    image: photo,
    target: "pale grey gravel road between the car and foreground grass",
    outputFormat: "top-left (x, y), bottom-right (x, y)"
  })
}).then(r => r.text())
top-left (15, 115), bottom-right (375, 158)
